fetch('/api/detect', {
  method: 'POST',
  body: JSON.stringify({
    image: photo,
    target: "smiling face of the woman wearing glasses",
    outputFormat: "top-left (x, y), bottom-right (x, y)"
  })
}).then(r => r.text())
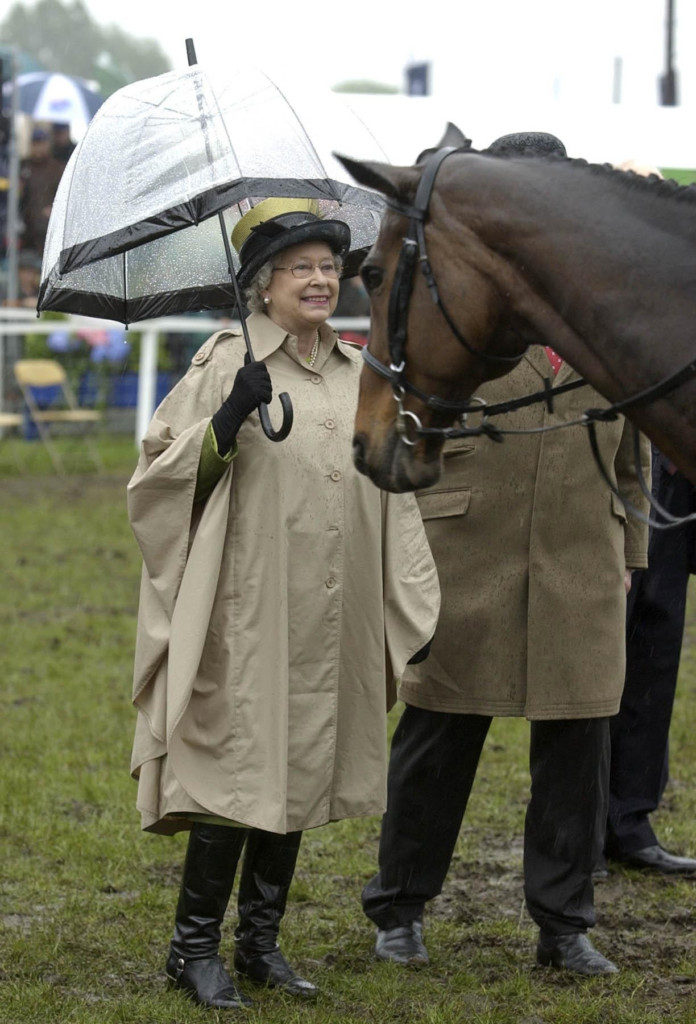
top-left (263, 242), bottom-right (339, 335)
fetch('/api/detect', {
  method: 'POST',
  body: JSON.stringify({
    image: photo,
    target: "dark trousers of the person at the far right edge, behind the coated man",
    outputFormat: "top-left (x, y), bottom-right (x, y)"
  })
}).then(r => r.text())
top-left (607, 460), bottom-right (694, 854)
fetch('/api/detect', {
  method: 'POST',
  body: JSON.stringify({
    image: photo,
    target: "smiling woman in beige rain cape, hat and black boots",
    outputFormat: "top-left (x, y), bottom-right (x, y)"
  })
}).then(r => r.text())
top-left (128, 200), bottom-right (439, 1008)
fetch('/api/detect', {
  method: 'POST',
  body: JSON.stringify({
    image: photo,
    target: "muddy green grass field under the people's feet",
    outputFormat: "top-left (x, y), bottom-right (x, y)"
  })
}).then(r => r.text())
top-left (0, 438), bottom-right (696, 1024)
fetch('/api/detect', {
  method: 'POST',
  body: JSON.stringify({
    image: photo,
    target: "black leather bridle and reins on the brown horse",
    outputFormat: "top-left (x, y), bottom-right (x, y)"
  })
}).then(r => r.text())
top-left (362, 146), bottom-right (696, 529)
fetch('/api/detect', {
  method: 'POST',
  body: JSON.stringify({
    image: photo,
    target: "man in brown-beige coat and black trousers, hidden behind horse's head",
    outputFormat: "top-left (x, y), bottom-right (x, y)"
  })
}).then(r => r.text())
top-left (363, 346), bottom-right (650, 974)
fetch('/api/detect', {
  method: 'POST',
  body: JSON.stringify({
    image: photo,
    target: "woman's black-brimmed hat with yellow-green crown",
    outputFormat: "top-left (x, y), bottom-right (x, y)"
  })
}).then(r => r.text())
top-left (232, 198), bottom-right (350, 288)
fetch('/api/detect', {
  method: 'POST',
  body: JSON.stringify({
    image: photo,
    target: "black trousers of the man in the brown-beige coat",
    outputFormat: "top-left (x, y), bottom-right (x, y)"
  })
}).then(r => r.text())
top-left (362, 706), bottom-right (609, 935)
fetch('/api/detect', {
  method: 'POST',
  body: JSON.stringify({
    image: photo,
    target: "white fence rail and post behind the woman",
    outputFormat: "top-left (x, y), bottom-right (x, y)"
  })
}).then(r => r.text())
top-left (0, 308), bottom-right (369, 446)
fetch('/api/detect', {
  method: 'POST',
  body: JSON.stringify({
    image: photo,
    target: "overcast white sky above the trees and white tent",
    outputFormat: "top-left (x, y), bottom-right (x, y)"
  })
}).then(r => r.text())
top-left (76, 0), bottom-right (696, 104)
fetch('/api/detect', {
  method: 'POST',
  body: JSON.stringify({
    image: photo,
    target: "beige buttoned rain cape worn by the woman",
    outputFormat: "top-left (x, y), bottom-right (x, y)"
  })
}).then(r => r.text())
top-left (128, 313), bottom-right (439, 833)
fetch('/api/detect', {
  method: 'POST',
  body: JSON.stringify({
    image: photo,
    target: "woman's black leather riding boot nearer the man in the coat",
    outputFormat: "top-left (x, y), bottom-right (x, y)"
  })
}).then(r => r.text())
top-left (234, 829), bottom-right (316, 998)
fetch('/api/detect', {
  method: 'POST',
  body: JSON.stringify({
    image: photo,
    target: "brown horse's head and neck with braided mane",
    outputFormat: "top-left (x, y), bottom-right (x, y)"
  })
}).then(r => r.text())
top-left (339, 133), bottom-right (696, 492)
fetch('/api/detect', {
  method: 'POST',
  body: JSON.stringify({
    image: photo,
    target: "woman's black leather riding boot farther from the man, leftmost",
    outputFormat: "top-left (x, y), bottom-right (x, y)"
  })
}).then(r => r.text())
top-left (166, 822), bottom-right (251, 1010)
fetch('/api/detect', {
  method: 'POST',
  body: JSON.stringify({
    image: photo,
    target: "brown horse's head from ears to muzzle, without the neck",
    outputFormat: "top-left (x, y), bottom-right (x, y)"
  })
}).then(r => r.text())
top-left (339, 146), bottom-right (527, 492)
